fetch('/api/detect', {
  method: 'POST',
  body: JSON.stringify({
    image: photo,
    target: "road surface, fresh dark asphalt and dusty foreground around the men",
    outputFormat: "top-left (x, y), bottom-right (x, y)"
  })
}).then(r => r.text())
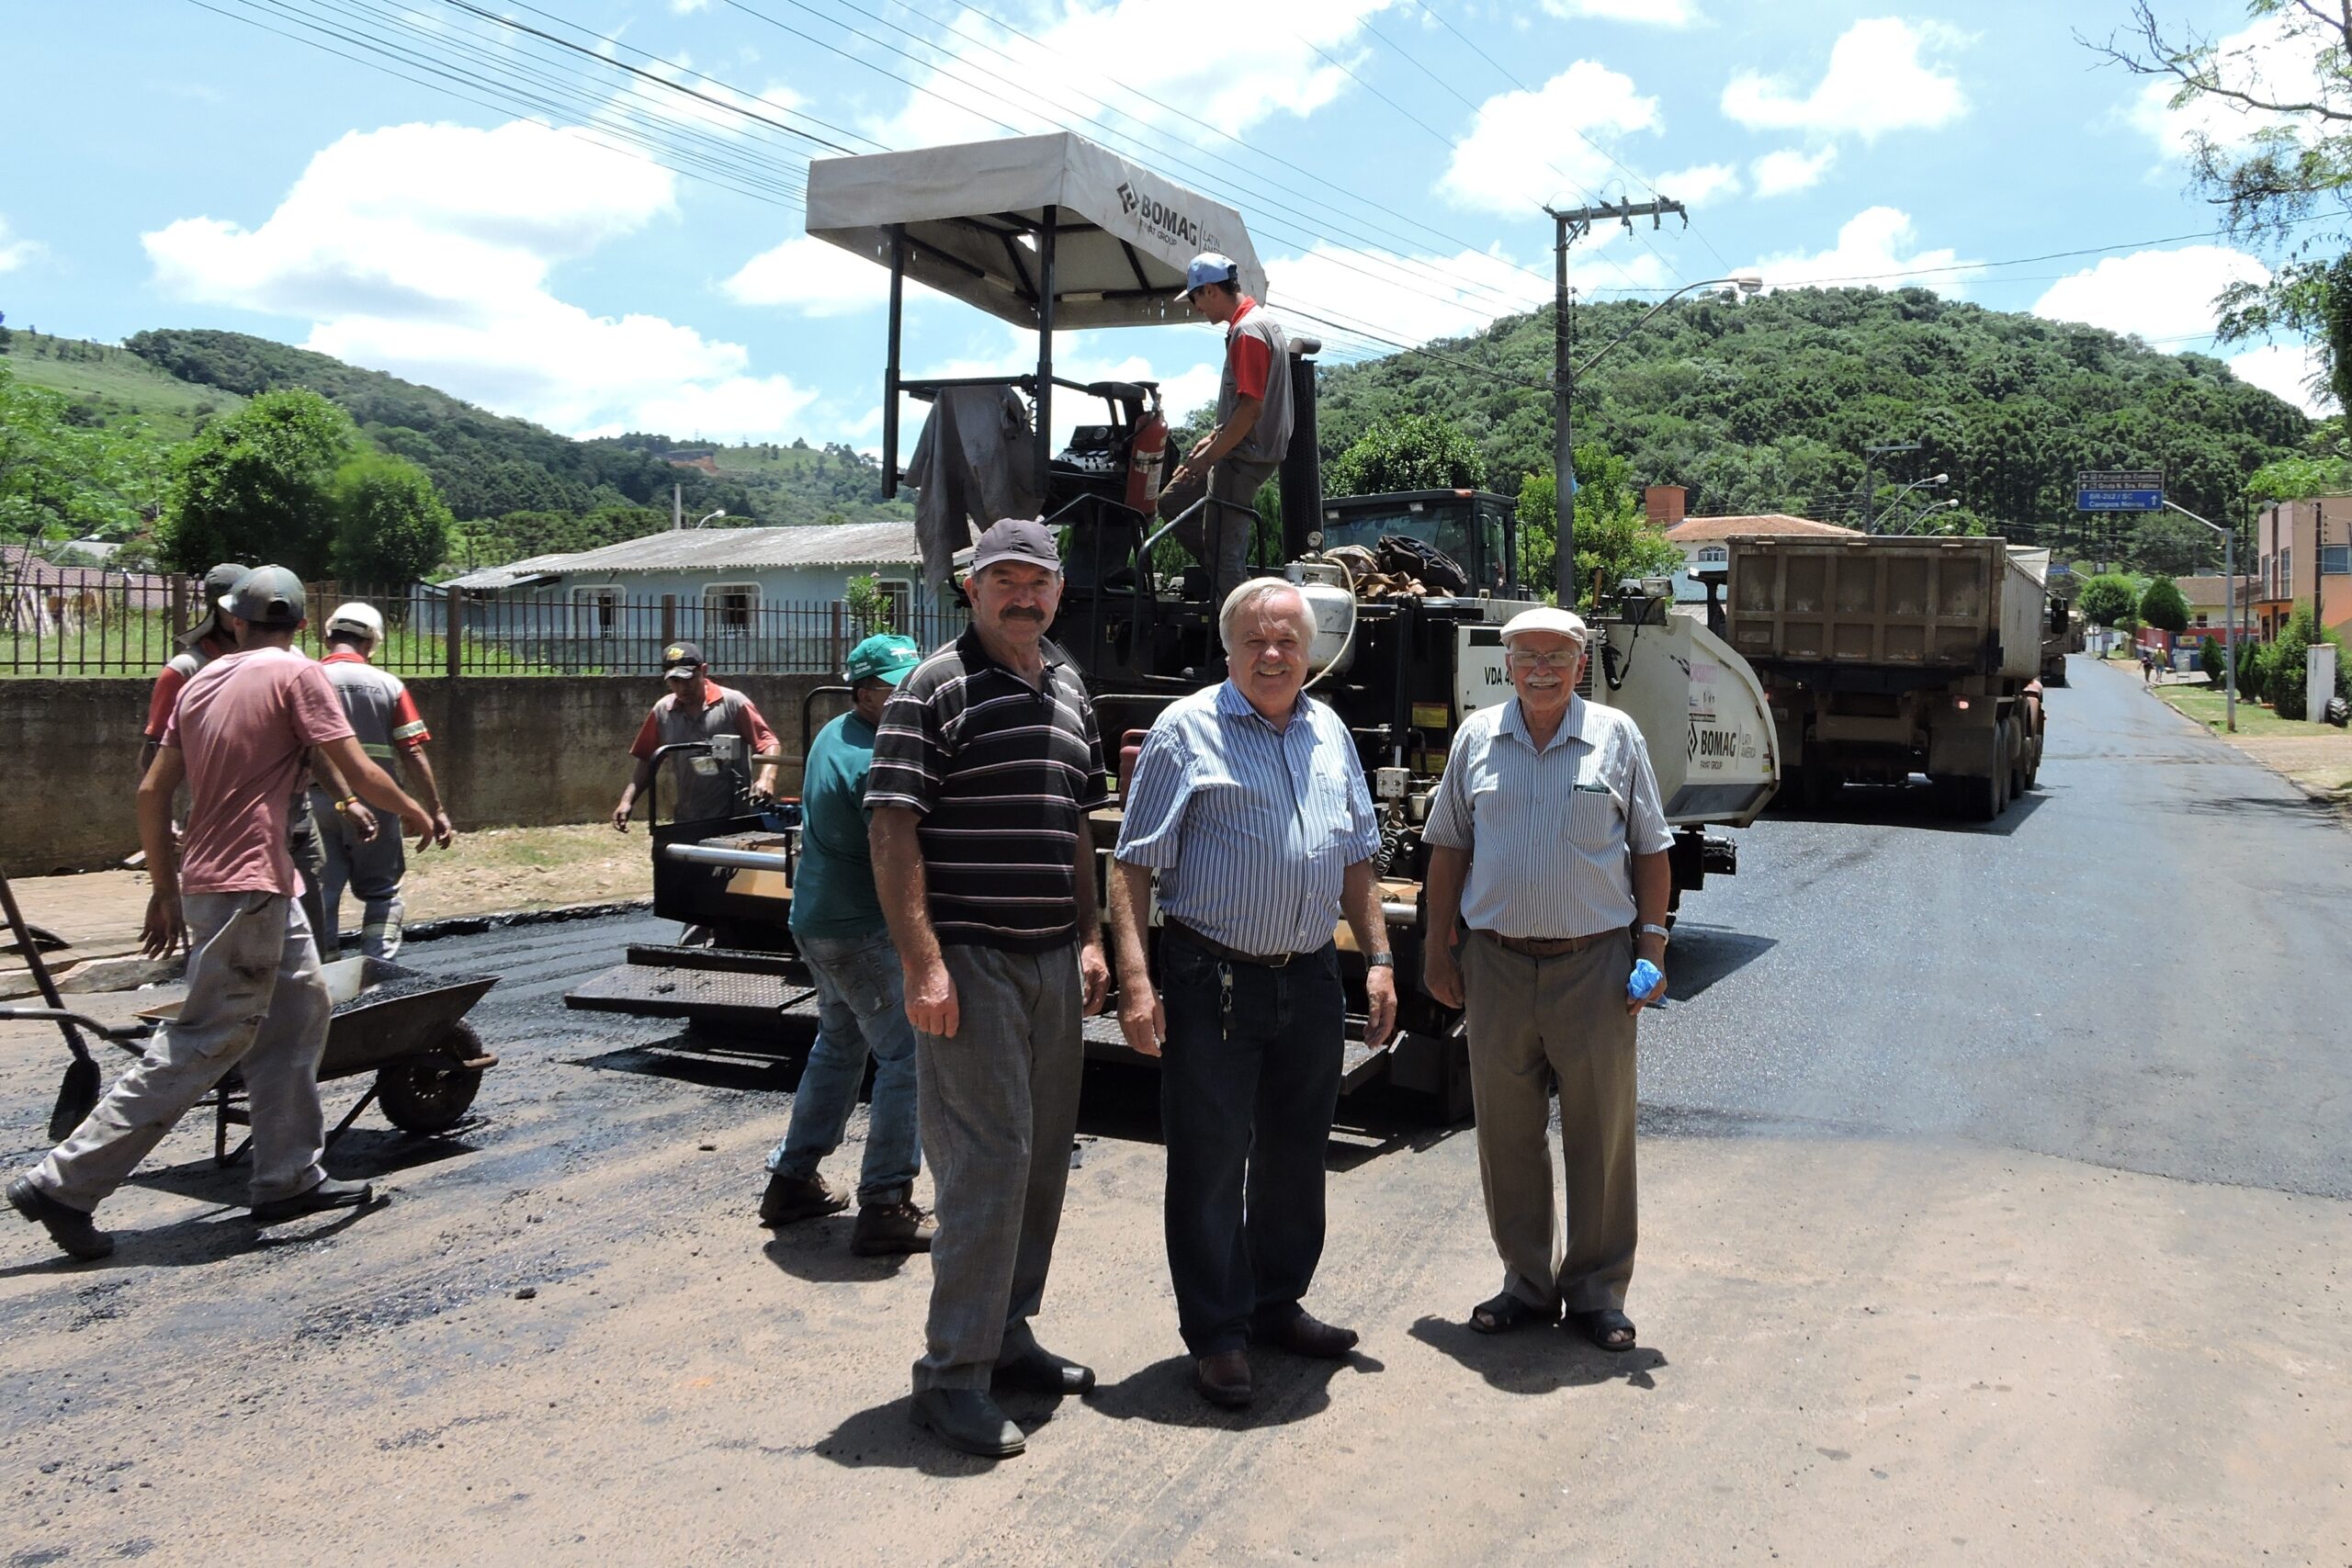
top-left (0, 660), bottom-right (2352, 1563)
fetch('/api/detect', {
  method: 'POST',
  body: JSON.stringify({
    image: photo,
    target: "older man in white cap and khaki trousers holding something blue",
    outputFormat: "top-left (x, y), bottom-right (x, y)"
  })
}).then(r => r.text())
top-left (1423, 609), bottom-right (1675, 1349)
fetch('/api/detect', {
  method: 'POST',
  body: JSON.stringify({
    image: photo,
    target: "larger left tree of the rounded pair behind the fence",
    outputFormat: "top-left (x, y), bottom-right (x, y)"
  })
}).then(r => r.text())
top-left (158, 390), bottom-right (357, 579)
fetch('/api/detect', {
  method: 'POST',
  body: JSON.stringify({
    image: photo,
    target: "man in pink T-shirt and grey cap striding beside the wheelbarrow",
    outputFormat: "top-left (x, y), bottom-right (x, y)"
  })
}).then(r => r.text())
top-left (7, 567), bottom-right (433, 1258)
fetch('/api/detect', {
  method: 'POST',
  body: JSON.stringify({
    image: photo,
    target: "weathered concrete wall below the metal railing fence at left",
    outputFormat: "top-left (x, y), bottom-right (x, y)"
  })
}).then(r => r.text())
top-left (0, 674), bottom-right (840, 877)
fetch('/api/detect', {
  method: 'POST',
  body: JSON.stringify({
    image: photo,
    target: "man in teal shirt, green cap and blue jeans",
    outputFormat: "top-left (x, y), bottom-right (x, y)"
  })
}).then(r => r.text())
top-left (760, 632), bottom-right (938, 1256)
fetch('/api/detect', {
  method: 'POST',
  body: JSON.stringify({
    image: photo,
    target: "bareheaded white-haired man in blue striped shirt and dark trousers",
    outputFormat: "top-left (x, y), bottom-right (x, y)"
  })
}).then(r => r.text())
top-left (1110, 579), bottom-right (1397, 1405)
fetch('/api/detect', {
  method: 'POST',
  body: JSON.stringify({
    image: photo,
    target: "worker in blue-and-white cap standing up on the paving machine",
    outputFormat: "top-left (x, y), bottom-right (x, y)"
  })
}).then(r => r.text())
top-left (1159, 252), bottom-right (1294, 604)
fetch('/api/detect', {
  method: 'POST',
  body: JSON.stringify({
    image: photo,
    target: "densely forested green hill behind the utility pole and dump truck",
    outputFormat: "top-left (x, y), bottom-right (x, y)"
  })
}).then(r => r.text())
top-left (1322, 289), bottom-right (2312, 543)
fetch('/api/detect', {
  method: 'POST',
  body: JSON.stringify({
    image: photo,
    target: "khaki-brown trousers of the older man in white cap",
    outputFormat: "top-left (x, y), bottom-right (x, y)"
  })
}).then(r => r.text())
top-left (1461, 933), bottom-right (1637, 1312)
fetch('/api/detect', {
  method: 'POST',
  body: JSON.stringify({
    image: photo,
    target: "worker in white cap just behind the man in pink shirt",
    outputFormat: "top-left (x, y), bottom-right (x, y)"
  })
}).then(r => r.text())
top-left (311, 600), bottom-right (457, 959)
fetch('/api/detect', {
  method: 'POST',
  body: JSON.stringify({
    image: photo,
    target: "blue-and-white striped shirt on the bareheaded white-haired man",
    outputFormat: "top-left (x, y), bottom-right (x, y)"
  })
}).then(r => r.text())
top-left (1117, 682), bottom-right (1381, 957)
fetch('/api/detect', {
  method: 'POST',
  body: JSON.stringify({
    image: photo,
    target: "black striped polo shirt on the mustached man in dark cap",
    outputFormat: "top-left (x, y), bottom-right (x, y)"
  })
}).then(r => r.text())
top-left (865, 630), bottom-right (1110, 952)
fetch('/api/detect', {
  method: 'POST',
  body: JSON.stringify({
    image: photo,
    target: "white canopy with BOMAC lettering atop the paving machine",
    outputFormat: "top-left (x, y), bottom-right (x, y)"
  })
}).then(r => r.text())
top-left (809, 131), bottom-right (1265, 332)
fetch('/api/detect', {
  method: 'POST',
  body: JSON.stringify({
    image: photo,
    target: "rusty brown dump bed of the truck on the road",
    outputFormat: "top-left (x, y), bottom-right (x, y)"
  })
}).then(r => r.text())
top-left (1724, 534), bottom-right (2044, 680)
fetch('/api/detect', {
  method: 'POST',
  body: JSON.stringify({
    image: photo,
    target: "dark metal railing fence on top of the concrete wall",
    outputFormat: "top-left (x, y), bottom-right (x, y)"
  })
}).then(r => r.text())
top-left (0, 566), bottom-right (965, 680)
